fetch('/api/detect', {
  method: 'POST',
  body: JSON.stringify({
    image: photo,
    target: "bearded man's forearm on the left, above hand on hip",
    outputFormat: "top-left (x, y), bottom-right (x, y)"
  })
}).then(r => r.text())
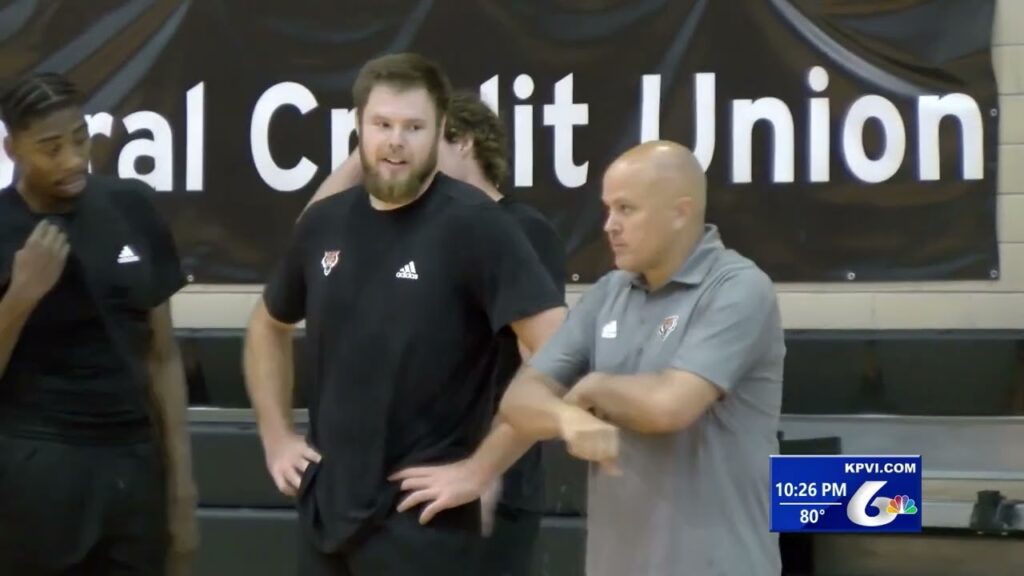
top-left (244, 313), bottom-right (295, 439)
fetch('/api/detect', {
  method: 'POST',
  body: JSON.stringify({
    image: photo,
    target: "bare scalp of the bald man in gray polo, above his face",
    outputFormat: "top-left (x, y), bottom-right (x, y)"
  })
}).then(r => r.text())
top-left (607, 140), bottom-right (708, 217)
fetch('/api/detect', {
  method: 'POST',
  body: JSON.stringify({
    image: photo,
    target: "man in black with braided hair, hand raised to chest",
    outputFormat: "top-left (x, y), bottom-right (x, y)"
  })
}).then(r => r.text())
top-left (0, 74), bottom-right (197, 576)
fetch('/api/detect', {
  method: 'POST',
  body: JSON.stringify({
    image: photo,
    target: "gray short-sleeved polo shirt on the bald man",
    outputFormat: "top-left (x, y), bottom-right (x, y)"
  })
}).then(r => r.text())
top-left (530, 225), bottom-right (785, 576)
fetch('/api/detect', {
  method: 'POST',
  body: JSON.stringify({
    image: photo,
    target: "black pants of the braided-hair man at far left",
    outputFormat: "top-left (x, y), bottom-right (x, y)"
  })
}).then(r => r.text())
top-left (0, 436), bottom-right (167, 576)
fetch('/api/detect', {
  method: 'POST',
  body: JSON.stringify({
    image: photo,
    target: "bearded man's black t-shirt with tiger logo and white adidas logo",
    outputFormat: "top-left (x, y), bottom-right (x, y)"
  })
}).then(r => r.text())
top-left (264, 173), bottom-right (563, 550)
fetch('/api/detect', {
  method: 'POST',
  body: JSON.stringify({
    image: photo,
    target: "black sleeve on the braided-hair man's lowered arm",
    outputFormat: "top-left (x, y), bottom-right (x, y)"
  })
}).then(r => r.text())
top-left (119, 180), bottom-right (188, 307)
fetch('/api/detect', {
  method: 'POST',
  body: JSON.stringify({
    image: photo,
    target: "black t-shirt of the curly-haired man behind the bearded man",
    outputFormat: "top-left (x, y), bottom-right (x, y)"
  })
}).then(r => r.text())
top-left (495, 197), bottom-right (565, 512)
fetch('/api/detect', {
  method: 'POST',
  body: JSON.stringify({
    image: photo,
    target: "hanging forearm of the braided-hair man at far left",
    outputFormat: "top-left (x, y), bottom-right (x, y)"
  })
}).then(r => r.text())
top-left (150, 347), bottom-right (196, 501)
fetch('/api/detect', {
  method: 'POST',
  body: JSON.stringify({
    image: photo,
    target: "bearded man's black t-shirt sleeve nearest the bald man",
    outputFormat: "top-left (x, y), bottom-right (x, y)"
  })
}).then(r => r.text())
top-left (467, 205), bottom-right (564, 333)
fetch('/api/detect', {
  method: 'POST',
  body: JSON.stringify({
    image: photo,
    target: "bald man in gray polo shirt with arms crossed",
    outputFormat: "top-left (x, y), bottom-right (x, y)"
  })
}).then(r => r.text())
top-left (502, 141), bottom-right (785, 576)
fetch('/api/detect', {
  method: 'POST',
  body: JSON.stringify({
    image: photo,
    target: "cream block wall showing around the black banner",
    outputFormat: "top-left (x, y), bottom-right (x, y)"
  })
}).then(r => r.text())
top-left (174, 0), bottom-right (1024, 329)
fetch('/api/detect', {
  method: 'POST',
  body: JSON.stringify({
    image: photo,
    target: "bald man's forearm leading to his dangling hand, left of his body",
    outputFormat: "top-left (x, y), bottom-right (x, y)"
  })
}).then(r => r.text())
top-left (499, 367), bottom-right (579, 442)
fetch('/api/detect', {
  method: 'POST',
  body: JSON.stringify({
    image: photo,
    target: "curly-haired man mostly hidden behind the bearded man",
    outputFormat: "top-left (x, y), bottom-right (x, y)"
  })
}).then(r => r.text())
top-left (309, 91), bottom-right (565, 576)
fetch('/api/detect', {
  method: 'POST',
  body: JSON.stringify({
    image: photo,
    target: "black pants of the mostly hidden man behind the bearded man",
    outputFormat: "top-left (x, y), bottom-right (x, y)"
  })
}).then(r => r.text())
top-left (480, 505), bottom-right (541, 576)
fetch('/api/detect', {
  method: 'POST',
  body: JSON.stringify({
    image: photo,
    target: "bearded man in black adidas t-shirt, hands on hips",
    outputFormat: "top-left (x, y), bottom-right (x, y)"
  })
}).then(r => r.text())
top-left (246, 54), bottom-right (564, 576)
